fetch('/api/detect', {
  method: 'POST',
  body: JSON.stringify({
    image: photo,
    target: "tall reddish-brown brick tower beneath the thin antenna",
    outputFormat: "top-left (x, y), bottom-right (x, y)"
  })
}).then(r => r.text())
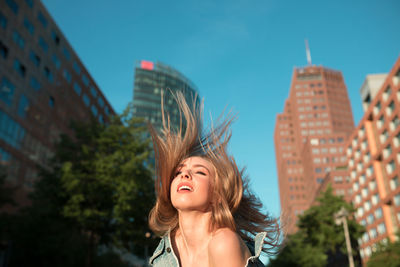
top-left (274, 65), bottom-right (354, 233)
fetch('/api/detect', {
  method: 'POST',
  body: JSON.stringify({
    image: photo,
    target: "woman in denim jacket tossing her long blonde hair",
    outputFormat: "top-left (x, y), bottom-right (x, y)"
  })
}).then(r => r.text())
top-left (149, 93), bottom-right (279, 267)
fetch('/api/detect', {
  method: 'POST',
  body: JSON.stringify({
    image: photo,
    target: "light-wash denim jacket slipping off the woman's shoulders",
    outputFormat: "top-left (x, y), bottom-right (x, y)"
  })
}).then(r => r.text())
top-left (149, 232), bottom-right (267, 267)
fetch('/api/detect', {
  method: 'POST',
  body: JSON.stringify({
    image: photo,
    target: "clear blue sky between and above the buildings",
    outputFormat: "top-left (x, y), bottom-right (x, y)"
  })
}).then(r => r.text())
top-left (42, 0), bottom-right (400, 220)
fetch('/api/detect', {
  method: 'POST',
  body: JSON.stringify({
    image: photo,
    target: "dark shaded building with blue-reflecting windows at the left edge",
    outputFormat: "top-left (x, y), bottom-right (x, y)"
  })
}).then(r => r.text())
top-left (0, 0), bottom-right (114, 204)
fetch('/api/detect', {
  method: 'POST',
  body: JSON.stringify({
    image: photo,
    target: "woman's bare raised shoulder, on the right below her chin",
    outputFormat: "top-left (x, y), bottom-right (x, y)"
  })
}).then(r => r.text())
top-left (208, 228), bottom-right (250, 267)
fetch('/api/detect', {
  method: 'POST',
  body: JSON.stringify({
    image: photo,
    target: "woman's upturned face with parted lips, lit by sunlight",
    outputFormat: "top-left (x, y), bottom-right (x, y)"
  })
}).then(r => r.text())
top-left (170, 157), bottom-right (215, 211)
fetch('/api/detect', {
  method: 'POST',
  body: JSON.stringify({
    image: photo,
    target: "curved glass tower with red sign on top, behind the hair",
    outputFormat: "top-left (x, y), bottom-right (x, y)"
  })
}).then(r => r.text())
top-left (133, 60), bottom-right (200, 132)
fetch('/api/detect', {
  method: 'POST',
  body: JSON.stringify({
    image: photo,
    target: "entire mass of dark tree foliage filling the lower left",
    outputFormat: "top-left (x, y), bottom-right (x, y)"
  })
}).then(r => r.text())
top-left (8, 105), bottom-right (155, 267)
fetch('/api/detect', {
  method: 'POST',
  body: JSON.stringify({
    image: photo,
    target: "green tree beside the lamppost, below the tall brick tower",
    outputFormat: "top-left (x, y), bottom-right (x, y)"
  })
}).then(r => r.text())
top-left (269, 187), bottom-right (363, 267)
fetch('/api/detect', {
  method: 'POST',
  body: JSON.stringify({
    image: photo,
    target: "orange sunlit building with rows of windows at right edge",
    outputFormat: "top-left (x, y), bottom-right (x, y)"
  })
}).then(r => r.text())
top-left (346, 55), bottom-right (400, 263)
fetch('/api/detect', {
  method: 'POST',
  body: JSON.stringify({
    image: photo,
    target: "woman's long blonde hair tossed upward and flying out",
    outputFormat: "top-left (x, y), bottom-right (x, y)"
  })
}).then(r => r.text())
top-left (149, 92), bottom-right (280, 254)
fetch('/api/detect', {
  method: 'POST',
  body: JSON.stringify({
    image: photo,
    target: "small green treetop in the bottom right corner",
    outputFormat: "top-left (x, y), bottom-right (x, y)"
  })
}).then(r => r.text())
top-left (367, 235), bottom-right (400, 267)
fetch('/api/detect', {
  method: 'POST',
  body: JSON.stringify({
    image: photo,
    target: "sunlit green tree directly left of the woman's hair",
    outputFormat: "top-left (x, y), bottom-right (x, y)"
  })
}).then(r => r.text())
top-left (61, 105), bottom-right (155, 266)
